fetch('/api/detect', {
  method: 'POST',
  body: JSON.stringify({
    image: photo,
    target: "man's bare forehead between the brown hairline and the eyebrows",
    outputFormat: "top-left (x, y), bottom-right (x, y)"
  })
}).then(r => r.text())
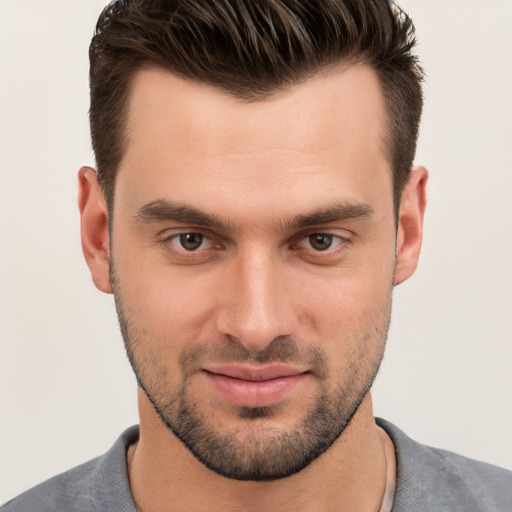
top-left (116, 65), bottom-right (392, 222)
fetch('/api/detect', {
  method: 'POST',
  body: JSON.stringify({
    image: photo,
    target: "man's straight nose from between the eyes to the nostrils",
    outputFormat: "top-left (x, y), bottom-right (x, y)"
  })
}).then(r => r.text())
top-left (217, 251), bottom-right (299, 351)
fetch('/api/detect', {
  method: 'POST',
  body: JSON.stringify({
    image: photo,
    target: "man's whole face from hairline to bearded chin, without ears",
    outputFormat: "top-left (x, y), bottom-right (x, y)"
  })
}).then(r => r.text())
top-left (80, 66), bottom-right (424, 480)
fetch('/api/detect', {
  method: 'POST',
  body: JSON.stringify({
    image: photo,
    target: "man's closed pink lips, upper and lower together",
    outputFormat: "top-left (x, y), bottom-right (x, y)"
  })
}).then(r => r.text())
top-left (203, 365), bottom-right (309, 407)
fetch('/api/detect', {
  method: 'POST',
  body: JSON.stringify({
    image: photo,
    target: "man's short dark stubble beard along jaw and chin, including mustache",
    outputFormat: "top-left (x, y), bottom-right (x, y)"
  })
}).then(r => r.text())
top-left (110, 262), bottom-right (391, 481)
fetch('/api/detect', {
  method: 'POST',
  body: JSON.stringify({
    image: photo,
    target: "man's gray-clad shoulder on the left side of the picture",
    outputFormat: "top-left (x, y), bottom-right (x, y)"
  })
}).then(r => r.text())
top-left (0, 427), bottom-right (138, 512)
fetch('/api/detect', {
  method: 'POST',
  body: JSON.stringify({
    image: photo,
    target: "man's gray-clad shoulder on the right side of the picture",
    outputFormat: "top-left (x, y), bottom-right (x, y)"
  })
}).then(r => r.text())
top-left (378, 420), bottom-right (512, 512)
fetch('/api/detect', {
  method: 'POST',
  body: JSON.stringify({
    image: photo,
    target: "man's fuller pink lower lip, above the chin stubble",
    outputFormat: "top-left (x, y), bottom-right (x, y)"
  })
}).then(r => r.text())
top-left (205, 372), bottom-right (307, 407)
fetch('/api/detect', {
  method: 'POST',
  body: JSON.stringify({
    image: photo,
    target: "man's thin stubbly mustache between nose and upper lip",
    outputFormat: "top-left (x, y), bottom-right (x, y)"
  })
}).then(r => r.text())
top-left (179, 335), bottom-right (328, 380)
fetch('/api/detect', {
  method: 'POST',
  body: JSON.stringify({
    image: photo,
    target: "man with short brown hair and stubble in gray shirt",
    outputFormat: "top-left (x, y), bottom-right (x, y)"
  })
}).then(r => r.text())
top-left (3, 0), bottom-right (512, 511)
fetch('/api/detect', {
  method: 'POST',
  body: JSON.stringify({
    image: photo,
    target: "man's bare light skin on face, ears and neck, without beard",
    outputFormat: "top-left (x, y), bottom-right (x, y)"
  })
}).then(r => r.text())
top-left (79, 66), bottom-right (427, 512)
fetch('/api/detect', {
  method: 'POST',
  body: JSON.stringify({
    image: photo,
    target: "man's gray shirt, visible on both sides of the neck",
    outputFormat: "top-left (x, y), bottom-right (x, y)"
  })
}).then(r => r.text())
top-left (0, 419), bottom-right (512, 512)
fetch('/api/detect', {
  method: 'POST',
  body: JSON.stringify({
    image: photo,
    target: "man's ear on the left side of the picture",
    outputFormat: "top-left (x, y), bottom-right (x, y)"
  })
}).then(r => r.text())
top-left (78, 167), bottom-right (112, 293)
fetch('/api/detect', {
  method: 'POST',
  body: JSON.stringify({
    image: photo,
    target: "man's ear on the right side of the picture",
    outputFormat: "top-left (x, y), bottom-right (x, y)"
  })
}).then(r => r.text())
top-left (395, 167), bottom-right (428, 285)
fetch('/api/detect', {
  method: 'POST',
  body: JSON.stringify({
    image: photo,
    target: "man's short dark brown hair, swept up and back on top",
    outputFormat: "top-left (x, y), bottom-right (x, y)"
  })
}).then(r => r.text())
top-left (89, 0), bottom-right (423, 212)
